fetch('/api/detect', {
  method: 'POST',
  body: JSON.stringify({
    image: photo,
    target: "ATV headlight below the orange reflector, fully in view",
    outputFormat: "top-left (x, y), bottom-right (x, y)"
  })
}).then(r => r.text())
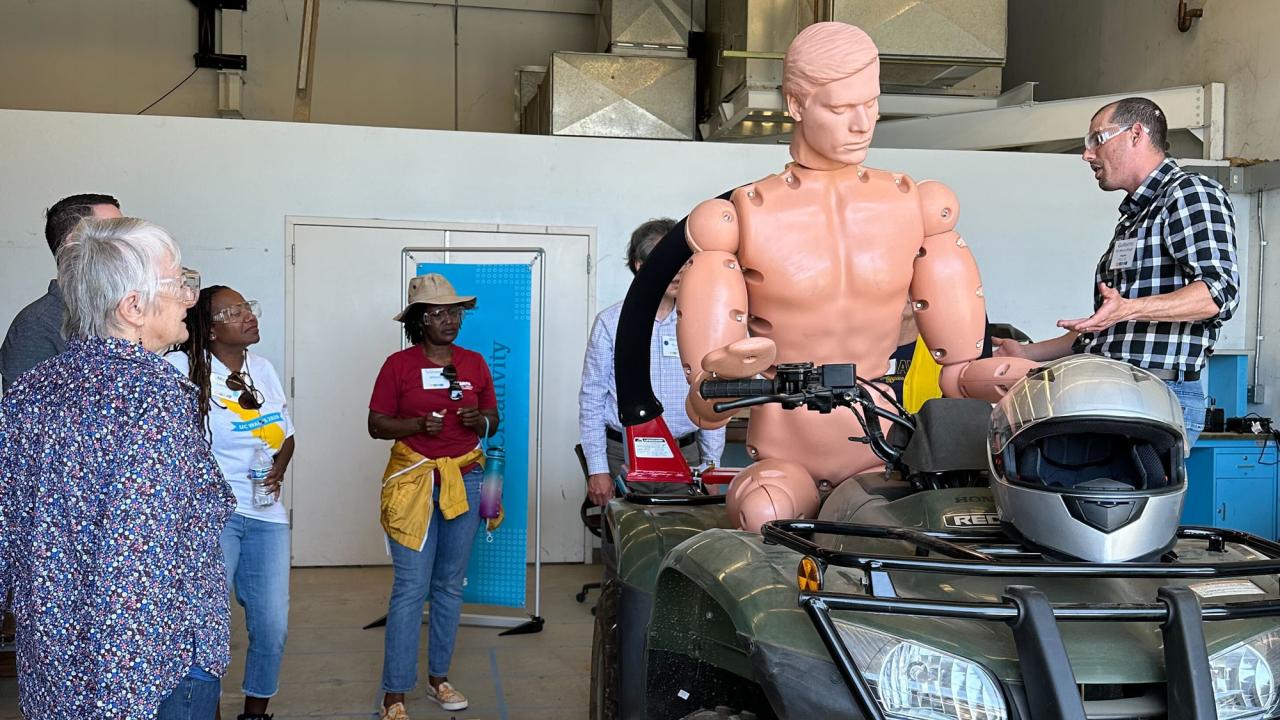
top-left (836, 620), bottom-right (1009, 720)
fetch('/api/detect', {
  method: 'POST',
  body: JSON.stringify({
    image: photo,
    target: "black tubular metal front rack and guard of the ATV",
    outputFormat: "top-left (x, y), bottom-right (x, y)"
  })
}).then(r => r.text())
top-left (762, 520), bottom-right (1280, 720)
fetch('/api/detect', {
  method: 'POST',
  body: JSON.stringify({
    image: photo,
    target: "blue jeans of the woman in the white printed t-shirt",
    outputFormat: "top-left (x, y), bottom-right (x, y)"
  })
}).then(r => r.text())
top-left (221, 514), bottom-right (289, 697)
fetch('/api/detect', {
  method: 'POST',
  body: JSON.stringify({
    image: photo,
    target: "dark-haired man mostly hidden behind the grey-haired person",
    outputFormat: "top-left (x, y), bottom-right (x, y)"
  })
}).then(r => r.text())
top-left (0, 193), bottom-right (120, 391)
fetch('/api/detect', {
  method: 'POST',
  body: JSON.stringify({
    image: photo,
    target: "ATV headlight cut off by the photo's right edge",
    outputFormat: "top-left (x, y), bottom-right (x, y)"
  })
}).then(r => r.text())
top-left (1208, 630), bottom-right (1280, 720)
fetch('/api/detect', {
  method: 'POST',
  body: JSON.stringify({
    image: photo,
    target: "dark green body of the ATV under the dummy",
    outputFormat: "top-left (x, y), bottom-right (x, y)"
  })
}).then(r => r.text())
top-left (593, 422), bottom-right (1280, 720)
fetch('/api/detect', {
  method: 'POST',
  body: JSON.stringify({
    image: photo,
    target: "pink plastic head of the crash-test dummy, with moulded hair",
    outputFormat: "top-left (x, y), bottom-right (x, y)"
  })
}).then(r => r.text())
top-left (782, 23), bottom-right (879, 169)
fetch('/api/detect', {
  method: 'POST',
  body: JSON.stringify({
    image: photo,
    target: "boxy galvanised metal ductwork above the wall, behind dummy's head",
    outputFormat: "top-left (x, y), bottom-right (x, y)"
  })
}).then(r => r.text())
top-left (516, 0), bottom-right (1007, 142)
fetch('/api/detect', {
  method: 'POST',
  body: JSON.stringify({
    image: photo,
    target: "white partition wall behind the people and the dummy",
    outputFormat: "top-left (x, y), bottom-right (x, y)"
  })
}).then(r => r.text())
top-left (0, 110), bottom-right (1254, 363)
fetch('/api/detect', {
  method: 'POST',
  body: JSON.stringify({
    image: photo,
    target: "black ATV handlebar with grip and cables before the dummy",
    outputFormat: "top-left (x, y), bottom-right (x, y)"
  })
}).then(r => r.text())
top-left (698, 363), bottom-right (915, 464)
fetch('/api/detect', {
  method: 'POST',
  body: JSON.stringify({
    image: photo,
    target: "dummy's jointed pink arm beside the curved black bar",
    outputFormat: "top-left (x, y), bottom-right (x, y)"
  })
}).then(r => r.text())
top-left (676, 199), bottom-right (774, 429)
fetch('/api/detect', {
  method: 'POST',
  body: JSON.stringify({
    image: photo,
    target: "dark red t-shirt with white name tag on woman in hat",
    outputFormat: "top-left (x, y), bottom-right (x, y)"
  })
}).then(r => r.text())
top-left (369, 345), bottom-right (498, 459)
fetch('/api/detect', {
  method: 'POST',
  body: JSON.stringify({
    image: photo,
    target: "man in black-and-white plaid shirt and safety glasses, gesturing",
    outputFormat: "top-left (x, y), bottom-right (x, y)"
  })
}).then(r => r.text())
top-left (993, 97), bottom-right (1240, 445)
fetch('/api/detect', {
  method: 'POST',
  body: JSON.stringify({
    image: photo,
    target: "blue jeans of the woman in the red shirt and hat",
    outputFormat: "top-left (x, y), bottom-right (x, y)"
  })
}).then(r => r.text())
top-left (383, 468), bottom-right (484, 693)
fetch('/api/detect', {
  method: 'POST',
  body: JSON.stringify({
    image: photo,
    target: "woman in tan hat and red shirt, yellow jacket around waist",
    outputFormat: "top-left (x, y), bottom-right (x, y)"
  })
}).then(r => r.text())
top-left (369, 273), bottom-right (498, 720)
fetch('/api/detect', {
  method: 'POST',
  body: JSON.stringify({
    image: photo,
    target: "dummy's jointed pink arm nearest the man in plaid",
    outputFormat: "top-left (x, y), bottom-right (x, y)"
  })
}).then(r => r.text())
top-left (910, 181), bottom-right (1036, 401)
